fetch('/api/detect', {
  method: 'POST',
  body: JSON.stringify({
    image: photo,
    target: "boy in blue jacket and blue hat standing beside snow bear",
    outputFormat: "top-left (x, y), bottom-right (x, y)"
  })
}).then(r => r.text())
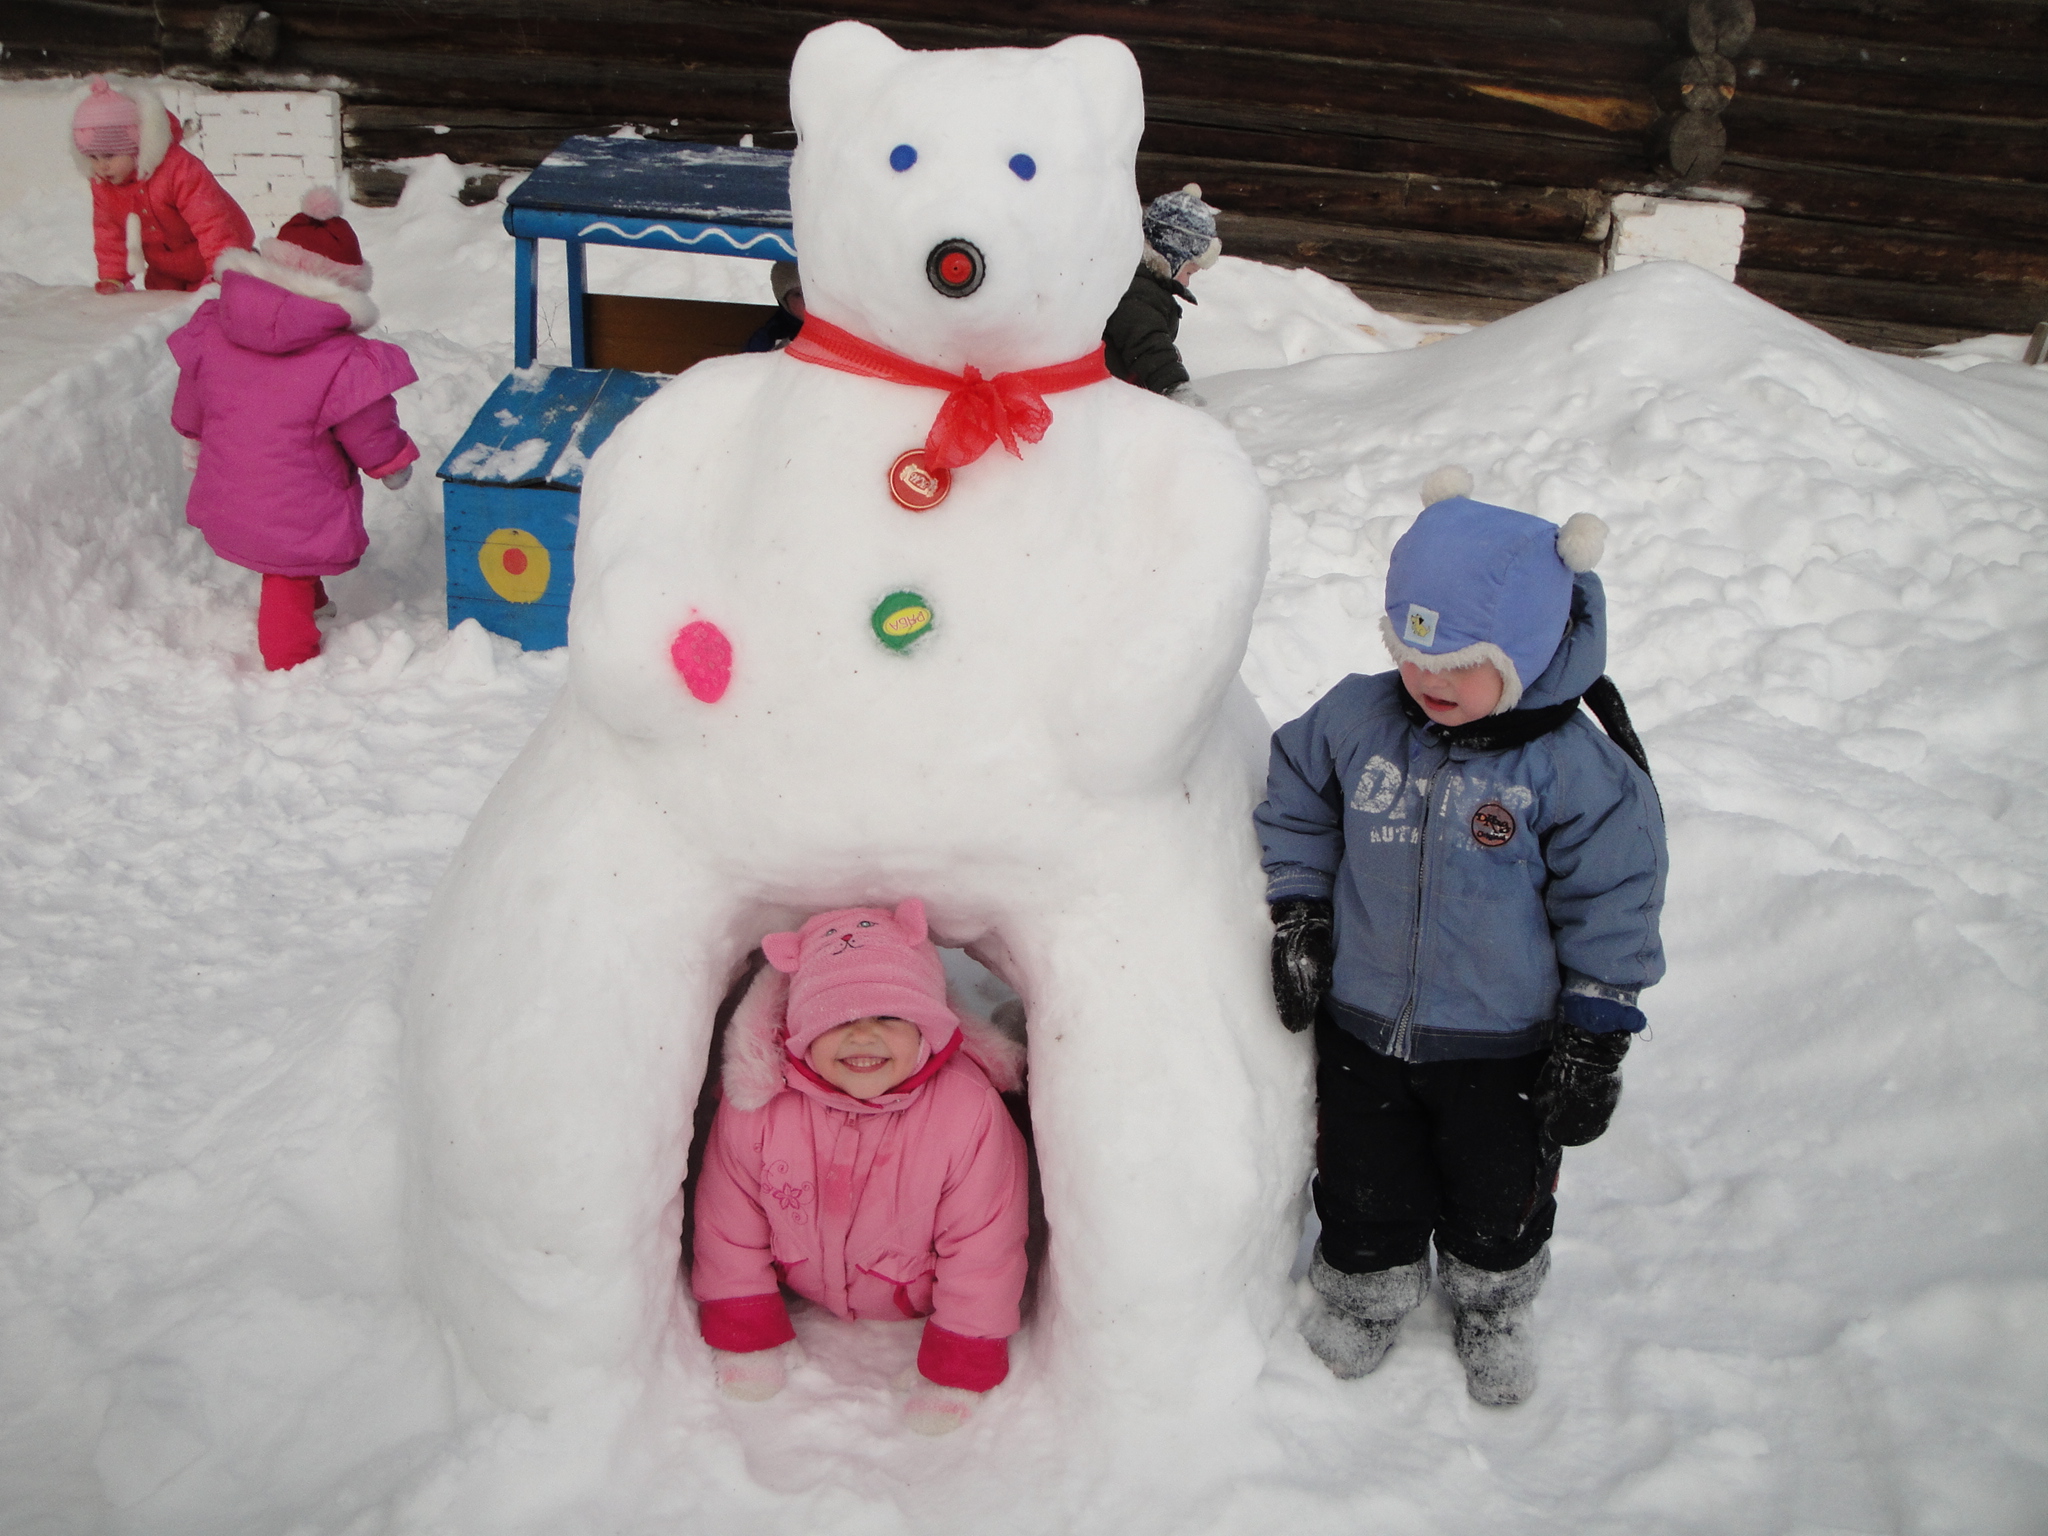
top-left (1257, 471), bottom-right (1665, 1407)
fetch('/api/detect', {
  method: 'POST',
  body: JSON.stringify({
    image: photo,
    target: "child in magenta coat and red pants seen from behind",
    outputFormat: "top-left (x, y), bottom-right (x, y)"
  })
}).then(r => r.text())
top-left (170, 188), bottom-right (420, 672)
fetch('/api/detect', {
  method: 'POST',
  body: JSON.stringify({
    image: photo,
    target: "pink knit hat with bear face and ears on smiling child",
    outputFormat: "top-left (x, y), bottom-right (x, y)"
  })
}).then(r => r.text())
top-left (762, 897), bottom-right (961, 1061)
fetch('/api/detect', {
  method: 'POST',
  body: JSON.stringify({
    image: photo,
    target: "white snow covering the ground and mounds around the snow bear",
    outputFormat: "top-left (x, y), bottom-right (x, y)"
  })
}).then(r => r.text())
top-left (0, 102), bottom-right (2048, 1536)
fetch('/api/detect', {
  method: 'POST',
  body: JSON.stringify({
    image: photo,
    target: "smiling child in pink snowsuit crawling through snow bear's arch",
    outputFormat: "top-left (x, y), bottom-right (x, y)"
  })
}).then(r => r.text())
top-left (690, 899), bottom-right (1026, 1434)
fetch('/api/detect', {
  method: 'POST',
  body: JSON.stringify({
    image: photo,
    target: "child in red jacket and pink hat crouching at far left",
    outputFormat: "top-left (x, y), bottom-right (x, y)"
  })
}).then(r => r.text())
top-left (72, 76), bottom-right (256, 293)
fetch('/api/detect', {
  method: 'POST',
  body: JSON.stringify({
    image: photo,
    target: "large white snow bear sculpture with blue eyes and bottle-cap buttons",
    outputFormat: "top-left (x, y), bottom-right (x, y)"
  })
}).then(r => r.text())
top-left (406, 23), bottom-right (1307, 1409)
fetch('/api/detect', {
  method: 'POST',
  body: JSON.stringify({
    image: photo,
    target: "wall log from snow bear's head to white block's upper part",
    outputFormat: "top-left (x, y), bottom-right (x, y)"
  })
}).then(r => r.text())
top-left (1139, 156), bottom-right (1608, 244)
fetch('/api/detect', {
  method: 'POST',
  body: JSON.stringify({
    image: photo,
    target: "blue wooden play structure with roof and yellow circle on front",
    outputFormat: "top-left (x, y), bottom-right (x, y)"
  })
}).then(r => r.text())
top-left (438, 137), bottom-right (797, 651)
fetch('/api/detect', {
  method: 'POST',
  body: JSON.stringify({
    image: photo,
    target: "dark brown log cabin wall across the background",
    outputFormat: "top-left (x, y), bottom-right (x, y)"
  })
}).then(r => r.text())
top-left (0, 0), bottom-right (2048, 346)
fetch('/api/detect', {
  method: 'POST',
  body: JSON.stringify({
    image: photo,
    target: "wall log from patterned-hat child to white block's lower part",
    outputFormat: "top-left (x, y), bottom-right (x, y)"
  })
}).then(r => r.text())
top-left (1217, 211), bottom-right (1599, 299)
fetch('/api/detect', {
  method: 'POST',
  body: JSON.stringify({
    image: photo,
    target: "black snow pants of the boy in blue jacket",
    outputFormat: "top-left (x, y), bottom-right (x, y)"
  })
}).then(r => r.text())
top-left (1315, 1010), bottom-right (1559, 1274)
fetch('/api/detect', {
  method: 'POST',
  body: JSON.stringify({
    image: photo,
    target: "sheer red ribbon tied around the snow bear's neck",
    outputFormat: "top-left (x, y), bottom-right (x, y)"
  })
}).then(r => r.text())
top-left (784, 315), bottom-right (1110, 469)
